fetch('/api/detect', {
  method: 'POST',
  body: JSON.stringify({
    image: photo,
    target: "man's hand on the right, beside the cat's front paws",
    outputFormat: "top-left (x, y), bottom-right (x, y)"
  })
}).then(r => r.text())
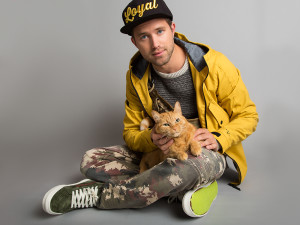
top-left (194, 128), bottom-right (219, 151)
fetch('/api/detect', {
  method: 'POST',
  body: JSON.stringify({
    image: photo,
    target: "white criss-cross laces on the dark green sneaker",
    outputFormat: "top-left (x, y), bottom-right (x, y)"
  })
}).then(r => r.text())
top-left (71, 187), bottom-right (98, 208)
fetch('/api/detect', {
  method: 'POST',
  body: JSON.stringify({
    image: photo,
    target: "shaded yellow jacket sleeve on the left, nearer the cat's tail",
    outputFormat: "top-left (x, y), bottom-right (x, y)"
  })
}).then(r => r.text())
top-left (123, 71), bottom-right (156, 152)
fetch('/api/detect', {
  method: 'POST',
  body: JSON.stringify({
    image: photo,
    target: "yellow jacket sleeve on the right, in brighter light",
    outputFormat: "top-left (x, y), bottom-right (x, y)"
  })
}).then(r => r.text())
top-left (210, 55), bottom-right (258, 153)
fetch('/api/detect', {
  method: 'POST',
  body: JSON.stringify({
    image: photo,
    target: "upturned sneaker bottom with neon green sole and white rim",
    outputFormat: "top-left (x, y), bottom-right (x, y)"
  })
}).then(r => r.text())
top-left (182, 181), bottom-right (218, 217)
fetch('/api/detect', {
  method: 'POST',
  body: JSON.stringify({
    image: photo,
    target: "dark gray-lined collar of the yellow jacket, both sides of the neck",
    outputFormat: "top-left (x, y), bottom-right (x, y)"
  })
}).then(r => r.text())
top-left (130, 33), bottom-right (209, 80)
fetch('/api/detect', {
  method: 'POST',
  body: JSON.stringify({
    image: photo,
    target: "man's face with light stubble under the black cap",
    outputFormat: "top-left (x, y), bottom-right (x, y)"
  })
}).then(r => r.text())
top-left (131, 18), bottom-right (175, 68)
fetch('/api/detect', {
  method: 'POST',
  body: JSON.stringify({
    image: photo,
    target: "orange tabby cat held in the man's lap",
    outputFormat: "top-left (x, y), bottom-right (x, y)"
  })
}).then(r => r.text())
top-left (140, 102), bottom-right (201, 173)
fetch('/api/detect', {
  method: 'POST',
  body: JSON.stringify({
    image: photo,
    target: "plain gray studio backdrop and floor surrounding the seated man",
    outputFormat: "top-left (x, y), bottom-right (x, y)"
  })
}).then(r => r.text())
top-left (0, 0), bottom-right (300, 225)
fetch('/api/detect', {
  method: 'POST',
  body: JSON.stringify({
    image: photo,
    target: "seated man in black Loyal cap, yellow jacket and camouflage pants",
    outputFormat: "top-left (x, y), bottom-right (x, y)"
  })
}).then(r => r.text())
top-left (43, 0), bottom-right (258, 217)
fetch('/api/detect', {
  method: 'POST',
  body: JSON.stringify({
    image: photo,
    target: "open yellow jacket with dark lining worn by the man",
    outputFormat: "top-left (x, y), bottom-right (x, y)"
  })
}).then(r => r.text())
top-left (123, 33), bottom-right (258, 185)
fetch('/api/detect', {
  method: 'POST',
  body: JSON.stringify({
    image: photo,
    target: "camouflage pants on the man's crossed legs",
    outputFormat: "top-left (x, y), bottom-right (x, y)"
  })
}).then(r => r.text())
top-left (81, 145), bottom-right (226, 209)
